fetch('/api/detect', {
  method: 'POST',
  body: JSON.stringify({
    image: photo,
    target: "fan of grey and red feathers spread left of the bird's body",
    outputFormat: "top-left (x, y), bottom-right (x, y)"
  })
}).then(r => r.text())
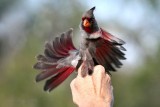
top-left (34, 29), bottom-right (78, 91)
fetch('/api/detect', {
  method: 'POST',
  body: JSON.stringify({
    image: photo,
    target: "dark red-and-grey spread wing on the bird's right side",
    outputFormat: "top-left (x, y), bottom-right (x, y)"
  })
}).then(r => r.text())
top-left (88, 30), bottom-right (126, 73)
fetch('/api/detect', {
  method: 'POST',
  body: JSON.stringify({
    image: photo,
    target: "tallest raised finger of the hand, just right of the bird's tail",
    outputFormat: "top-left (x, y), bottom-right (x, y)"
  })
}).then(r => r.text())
top-left (92, 65), bottom-right (105, 95)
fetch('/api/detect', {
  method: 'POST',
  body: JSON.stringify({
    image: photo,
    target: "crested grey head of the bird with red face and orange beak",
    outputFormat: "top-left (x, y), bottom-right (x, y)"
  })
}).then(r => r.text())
top-left (81, 7), bottom-right (99, 34)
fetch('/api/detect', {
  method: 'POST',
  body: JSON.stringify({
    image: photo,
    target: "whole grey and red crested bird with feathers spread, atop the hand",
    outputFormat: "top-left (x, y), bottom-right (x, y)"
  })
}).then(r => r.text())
top-left (33, 6), bottom-right (126, 92)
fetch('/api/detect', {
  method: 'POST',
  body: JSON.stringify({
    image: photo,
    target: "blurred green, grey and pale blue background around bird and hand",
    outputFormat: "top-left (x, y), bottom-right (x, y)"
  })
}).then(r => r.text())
top-left (0, 0), bottom-right (160, 107)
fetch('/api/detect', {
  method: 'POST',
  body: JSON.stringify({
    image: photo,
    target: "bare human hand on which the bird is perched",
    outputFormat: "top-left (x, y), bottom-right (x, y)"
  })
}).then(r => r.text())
top-left (70, 65), bottom-right (114, 107)
